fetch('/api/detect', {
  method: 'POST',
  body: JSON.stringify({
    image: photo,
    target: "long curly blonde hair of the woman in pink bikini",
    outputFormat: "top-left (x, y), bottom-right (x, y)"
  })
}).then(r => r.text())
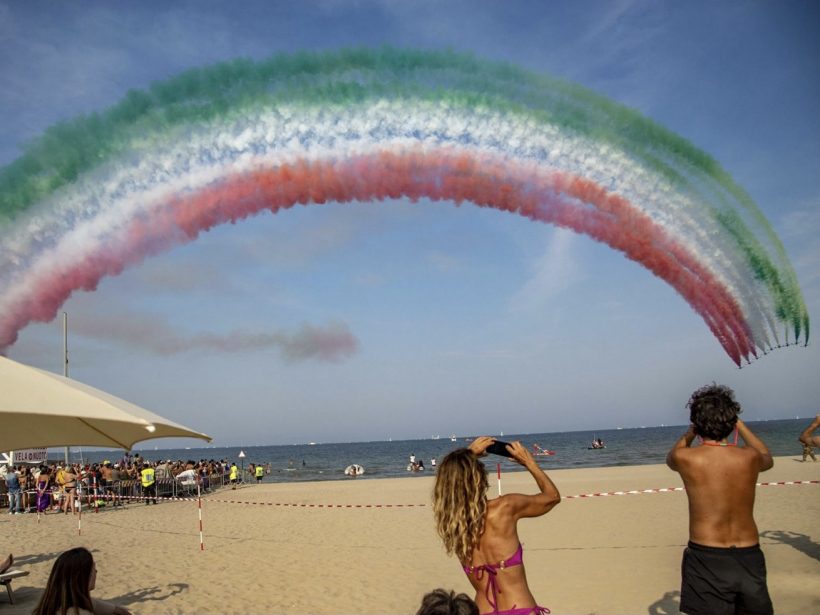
top-left (433, 448), bottom-right (488, 564)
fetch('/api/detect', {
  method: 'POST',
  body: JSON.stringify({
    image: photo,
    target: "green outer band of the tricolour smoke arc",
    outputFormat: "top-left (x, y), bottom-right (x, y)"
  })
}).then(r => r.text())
top-left (0, 48), bottom-right (809, 341)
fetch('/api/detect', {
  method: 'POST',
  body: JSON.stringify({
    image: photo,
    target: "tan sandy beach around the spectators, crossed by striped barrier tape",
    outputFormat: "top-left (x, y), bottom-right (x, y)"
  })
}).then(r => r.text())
top-left (0, 457), bottom-right (820, 615)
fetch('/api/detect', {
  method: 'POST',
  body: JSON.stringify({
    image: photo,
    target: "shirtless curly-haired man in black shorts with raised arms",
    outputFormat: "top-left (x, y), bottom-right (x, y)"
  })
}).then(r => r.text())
top-left (666, 384), bottom-right (774, 615)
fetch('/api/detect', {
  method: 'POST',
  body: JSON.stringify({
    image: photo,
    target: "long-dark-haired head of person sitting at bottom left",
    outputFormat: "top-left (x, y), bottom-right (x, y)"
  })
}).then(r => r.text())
top-left (32, 547), bottom-right (97, 615)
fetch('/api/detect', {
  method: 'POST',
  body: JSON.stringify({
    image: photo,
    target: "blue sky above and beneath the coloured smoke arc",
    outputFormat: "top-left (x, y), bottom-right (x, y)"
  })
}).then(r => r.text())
top-left (0, 0), bottom-right (820, 446)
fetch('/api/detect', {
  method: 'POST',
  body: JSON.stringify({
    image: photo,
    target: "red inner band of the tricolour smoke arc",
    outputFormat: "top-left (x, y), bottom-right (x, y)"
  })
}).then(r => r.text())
top-left (0, 148), bottom-right (755, 365)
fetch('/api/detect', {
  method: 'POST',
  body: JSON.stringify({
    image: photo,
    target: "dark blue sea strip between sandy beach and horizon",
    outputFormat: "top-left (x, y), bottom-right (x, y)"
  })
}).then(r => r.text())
top-left (62, 419), bottom-right (811, 483)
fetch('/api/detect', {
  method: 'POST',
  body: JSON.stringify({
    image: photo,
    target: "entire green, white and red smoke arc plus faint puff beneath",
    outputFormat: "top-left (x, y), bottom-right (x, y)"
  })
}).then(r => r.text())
top-left (0, 49), bottom-right (809, 365)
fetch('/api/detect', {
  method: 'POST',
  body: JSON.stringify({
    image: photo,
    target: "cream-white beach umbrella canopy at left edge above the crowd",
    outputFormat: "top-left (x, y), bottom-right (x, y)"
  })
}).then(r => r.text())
top-left (0, 357), bottom-right (211, 451)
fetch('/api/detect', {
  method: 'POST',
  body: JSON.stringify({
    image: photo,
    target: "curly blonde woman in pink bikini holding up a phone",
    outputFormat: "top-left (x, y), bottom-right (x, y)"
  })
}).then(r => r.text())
top-left (433, 436), bottom-right (561, 615)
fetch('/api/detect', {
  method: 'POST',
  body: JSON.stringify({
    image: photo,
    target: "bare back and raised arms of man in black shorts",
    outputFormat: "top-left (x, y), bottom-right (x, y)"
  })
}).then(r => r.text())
top-left (667, 419), bottom-right (773, 547)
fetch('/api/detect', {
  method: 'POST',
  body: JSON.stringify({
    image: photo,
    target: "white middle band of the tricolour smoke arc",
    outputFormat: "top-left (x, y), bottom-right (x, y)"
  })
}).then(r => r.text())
top-left (0, 101), bottom-right (773, 352)
